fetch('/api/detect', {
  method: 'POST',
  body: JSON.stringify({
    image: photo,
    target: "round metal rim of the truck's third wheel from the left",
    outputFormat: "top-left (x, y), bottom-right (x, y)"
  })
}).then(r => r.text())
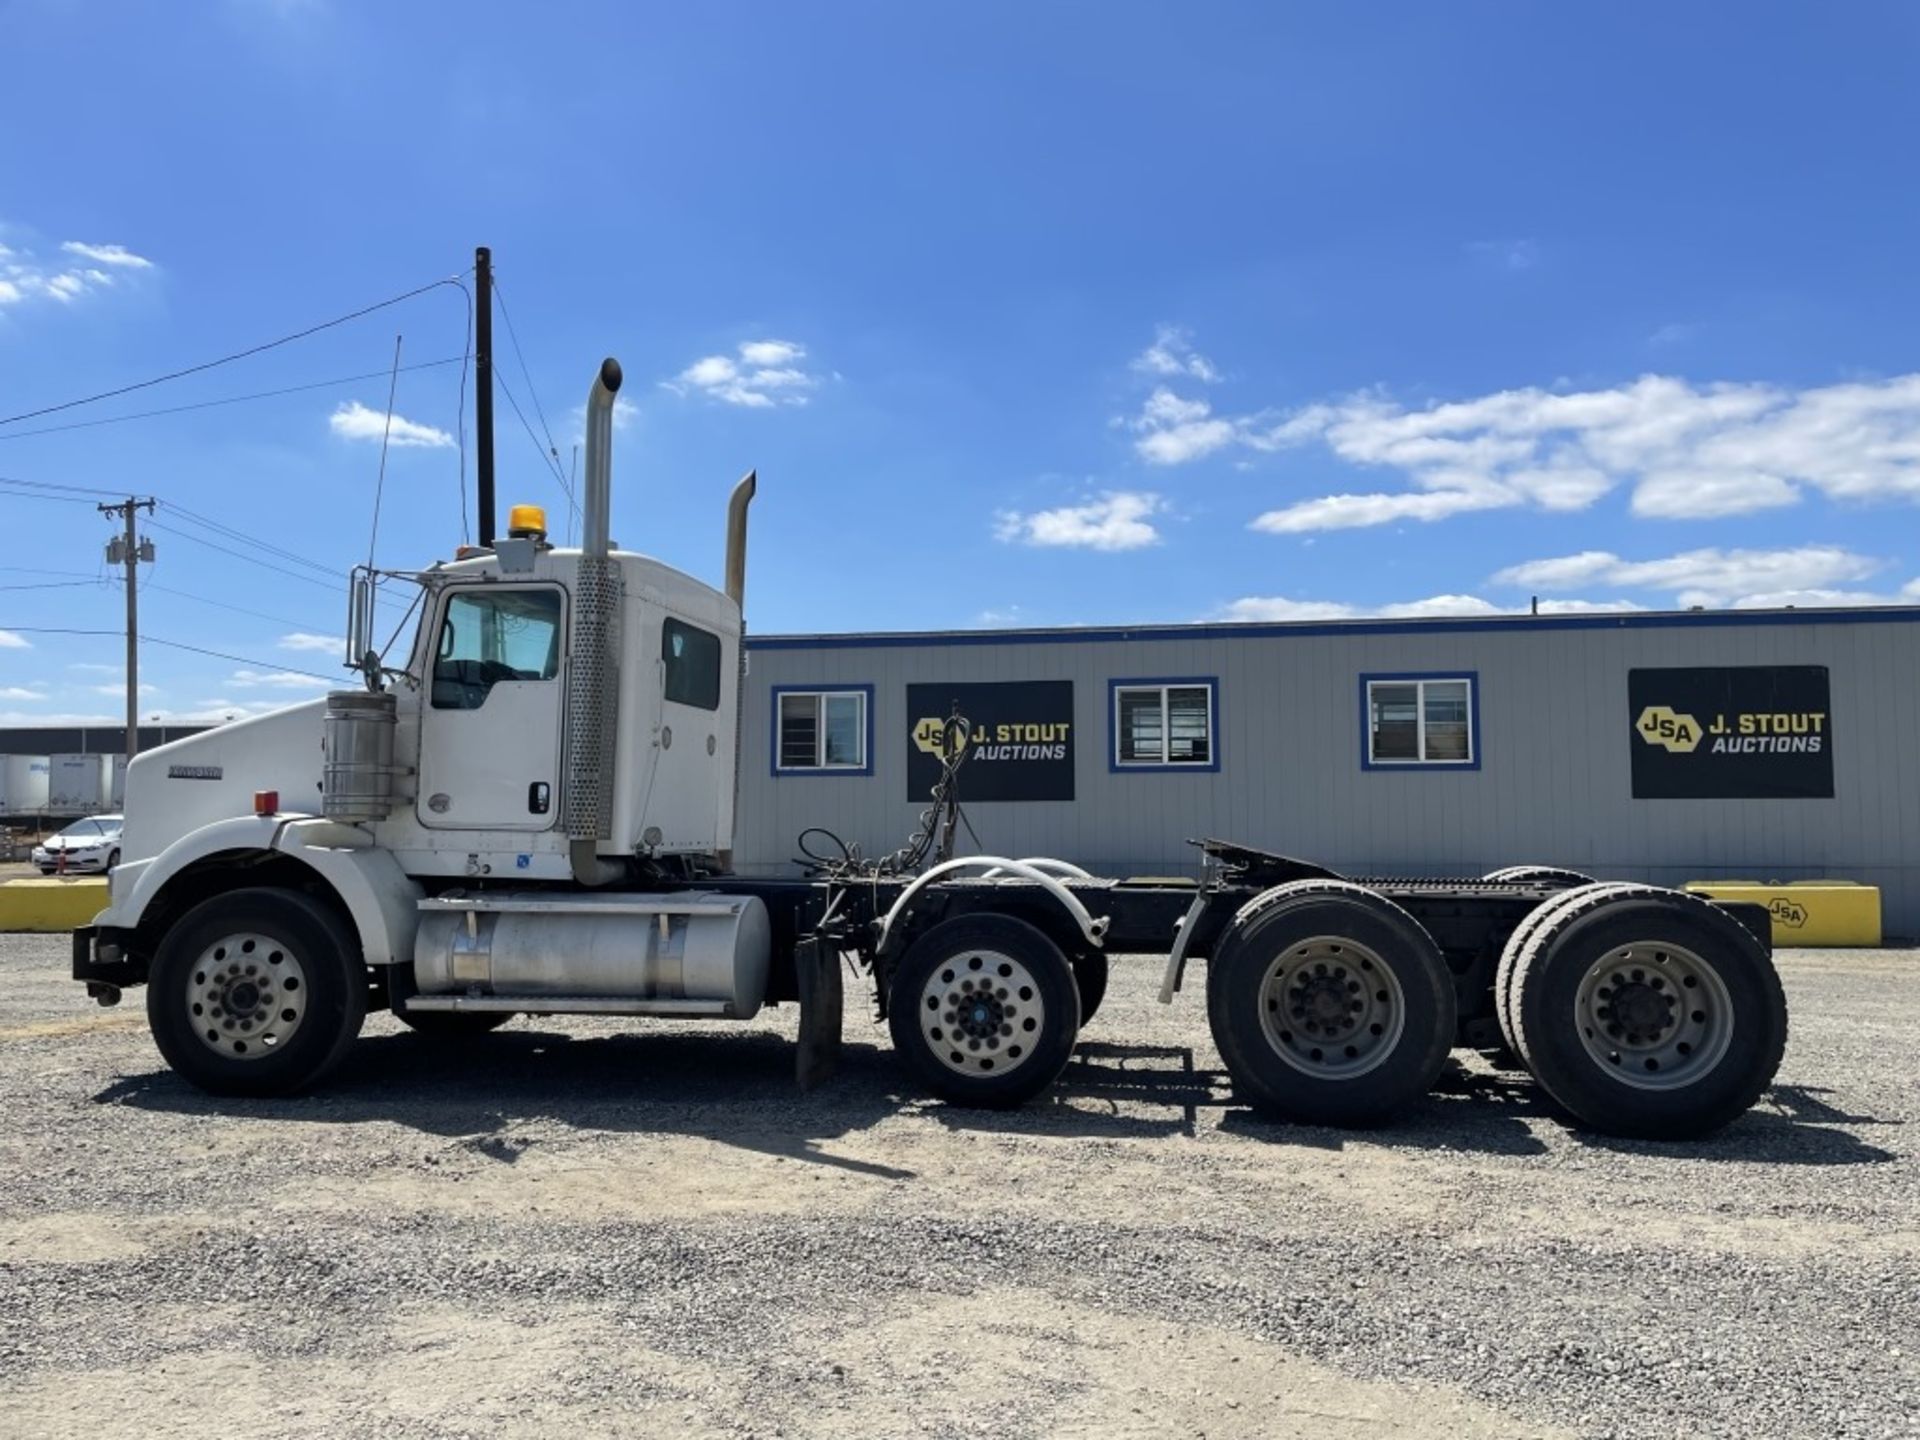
top-left (1260, 935), bottom-right (1407, 1079)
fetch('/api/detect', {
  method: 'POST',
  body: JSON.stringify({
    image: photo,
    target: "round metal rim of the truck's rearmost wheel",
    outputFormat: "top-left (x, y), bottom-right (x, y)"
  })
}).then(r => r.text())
top-left (1572, 941), bottom-right (1734, 1091)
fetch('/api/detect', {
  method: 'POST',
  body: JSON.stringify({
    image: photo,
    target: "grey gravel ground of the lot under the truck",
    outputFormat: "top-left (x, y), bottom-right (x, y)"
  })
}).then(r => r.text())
top-left (0, 937), bottom-right (1920, 1440)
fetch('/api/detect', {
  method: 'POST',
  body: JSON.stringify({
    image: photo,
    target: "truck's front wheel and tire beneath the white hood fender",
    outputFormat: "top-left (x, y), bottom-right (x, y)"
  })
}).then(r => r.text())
top-left (146, 887), bottom-right (367, 1094)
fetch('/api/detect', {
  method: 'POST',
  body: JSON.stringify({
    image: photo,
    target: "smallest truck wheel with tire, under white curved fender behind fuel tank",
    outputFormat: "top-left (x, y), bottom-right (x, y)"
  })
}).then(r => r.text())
top-left (887, 916), bottom-right (1081, 1108)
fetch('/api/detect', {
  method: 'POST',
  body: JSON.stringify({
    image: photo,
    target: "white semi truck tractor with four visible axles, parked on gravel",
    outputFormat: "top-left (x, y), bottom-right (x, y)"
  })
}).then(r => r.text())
top-left (73, 359), bottom-right (1786, 1137)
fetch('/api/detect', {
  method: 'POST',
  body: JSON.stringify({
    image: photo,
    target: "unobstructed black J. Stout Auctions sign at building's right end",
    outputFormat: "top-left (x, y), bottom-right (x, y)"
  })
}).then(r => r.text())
top-left (1626, 664), bottom-right (1834, 801)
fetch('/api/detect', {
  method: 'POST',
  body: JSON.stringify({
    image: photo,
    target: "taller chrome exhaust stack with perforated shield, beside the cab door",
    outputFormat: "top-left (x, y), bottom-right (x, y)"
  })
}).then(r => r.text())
top-left (561, 357), bottom-right (626, 885)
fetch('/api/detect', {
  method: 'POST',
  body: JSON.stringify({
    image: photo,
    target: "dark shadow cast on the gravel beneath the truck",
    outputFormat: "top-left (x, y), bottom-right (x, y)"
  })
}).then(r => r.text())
top-left (94, 1025), bottom-right (1893, 1181)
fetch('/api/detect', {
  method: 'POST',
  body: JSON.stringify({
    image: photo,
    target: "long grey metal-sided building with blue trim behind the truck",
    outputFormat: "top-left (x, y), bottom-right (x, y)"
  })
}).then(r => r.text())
top-left (737, 609), bottom-right (1920, 935)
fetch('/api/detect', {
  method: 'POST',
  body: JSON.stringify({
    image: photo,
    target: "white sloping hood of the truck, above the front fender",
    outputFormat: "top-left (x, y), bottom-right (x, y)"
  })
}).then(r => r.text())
top-left (121, 699), bottom-right (326, 860)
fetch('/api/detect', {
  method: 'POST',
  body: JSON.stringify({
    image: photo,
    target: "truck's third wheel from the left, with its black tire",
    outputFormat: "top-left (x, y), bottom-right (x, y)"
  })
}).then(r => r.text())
top-left (1208, 879), bottom-right (1457, 1125)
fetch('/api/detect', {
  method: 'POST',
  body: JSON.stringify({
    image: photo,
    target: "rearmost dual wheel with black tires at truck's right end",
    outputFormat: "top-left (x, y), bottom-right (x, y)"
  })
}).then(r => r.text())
top-left (1507, 885), bottom-right (1788, 1140)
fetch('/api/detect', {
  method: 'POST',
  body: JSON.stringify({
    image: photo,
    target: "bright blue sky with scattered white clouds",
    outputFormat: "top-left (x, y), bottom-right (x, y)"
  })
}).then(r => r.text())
top-left (0, 0), bottom-right (1920, 724)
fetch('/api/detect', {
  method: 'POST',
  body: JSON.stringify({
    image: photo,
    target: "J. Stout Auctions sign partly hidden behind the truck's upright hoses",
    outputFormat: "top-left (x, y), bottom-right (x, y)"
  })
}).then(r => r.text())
top-left (906, 680), bottom-right (1073, 803)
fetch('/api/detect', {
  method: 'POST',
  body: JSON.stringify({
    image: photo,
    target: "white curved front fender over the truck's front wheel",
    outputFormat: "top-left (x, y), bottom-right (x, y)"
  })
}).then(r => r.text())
top-left (94, 816), bottom-right (424, 966)
